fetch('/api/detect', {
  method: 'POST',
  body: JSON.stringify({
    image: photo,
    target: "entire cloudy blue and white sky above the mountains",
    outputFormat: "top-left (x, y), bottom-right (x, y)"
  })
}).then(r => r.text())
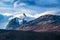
top-left (0, 0), bottom-right (60, 29)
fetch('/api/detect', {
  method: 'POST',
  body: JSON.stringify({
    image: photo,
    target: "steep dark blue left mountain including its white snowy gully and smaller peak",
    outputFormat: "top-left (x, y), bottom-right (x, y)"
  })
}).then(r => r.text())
top-left (6, 17), bottom-right (26, 30)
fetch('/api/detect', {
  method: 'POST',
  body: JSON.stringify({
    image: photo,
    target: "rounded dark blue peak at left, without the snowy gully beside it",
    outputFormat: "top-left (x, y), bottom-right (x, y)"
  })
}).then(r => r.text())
top-left (7, 18), bottom-right (20, 30)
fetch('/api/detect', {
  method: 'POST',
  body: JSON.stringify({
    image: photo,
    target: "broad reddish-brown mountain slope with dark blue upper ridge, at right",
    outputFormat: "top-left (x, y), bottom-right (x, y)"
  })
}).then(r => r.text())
top-left (16, 15), bottom-right (60, 31)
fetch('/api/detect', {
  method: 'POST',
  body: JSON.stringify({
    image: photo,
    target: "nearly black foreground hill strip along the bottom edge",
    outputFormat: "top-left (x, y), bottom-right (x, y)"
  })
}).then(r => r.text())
top-left (0, 30), bottom-right (60, 40)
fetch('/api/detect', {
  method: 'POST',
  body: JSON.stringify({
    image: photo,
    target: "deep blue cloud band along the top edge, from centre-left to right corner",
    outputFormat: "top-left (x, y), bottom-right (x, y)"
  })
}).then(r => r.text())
top-left (12, 0), bottom-right (60, 6)
